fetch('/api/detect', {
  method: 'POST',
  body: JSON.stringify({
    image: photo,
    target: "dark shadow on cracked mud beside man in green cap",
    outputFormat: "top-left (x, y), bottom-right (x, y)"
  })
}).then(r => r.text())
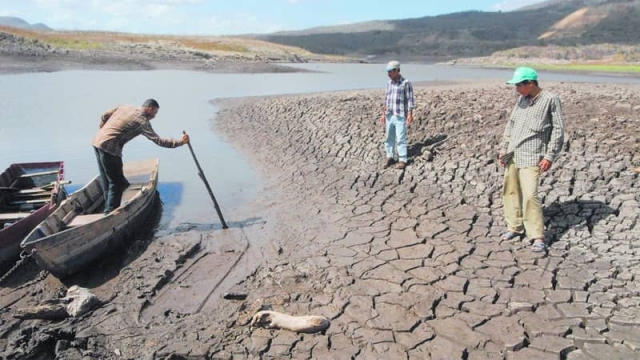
top-left (543, 200), bottom-right (618, 244)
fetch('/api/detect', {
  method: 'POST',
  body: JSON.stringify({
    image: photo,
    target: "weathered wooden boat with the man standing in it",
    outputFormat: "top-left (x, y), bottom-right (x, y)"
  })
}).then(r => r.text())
top-left (21, 159), bottom-right (158, 277)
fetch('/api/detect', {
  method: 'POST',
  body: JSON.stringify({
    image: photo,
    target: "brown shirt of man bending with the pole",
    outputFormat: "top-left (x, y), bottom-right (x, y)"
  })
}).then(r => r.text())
top-left (92, 105), bottom-right (181, 156)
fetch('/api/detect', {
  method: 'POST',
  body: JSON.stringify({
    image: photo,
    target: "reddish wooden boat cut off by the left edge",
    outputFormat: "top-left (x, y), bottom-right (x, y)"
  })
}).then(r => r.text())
top-left (0, 161), bottom-right (67, 270)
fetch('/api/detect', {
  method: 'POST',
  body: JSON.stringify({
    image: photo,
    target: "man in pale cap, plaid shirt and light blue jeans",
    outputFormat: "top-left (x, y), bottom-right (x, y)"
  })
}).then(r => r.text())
top-left (380, 60), bottom-right (414, 170)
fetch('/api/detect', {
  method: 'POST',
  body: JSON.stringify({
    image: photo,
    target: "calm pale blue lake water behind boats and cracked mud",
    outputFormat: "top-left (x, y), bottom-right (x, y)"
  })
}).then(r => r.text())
top-left (0, 64), bottom-right (638, 230)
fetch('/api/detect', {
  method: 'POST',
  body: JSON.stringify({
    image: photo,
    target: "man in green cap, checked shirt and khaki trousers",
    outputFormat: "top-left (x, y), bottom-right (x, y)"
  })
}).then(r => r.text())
top-left (498, 67), bottom-right (564, 252)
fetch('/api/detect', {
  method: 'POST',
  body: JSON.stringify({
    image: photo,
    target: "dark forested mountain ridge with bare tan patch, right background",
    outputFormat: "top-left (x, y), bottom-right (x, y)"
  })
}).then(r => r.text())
top-left (252, 0), bottom-right (640, 59)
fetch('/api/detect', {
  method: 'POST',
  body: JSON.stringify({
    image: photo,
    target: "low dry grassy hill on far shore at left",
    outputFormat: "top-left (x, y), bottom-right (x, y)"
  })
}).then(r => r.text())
top-left (0, 26), bottom-right (353, 73)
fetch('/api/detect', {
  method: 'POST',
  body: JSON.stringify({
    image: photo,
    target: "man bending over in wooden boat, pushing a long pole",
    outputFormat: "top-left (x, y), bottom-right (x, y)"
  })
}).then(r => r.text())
top-left (92, 99), bottom-right (189, 214)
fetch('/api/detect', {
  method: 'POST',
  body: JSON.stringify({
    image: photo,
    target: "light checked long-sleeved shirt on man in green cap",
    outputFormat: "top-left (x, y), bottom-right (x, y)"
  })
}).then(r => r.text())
top-left (500, 90), bottom-right (564, 168)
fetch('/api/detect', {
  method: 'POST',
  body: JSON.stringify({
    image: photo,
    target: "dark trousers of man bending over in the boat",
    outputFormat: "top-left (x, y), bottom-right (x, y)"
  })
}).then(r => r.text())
top-left (94, 147), bottom-right (129, 214)
